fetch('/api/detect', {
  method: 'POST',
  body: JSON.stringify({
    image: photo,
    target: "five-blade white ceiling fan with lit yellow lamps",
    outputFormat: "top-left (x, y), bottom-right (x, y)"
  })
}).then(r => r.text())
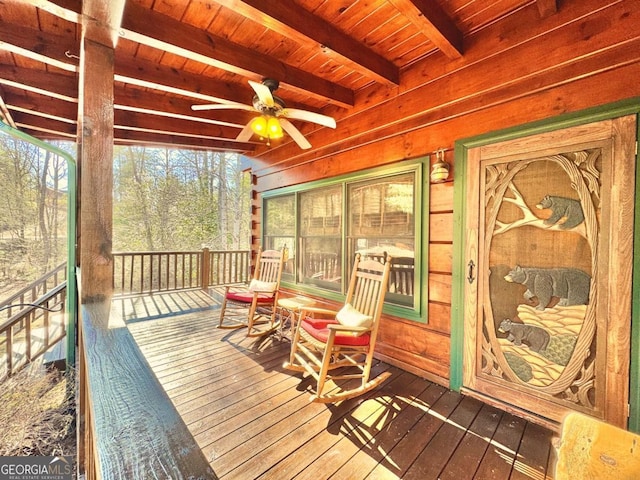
top-left (191, 78), bottom-right (336, 150)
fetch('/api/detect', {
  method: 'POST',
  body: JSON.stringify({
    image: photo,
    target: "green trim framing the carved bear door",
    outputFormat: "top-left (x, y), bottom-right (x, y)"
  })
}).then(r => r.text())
top-left (449, 97), bottom-right (640, 432)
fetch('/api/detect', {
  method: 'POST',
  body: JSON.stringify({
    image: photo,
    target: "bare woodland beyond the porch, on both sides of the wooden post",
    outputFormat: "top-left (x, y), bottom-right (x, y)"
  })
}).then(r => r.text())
top-left (0, 135), bottom-right (251, 299)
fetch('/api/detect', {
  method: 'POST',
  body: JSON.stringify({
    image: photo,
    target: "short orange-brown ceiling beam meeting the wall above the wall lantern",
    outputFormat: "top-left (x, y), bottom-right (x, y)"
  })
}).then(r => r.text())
top-left (389, 0), bottom-right (463, 59)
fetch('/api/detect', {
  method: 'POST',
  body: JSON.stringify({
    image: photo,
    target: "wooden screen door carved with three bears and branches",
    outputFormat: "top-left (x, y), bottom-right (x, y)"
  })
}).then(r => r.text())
top-left (463, 116), bottom-right (636, 426)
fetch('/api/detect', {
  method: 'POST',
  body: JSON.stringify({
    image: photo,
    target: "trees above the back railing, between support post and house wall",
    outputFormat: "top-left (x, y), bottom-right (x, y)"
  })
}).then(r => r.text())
top-left (113, 146), bottom-right (250, 251)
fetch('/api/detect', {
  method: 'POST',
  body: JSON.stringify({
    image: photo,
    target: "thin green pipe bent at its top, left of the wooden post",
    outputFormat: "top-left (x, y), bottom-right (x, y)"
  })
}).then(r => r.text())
top-left (0, 121), bottom-right (78, 368)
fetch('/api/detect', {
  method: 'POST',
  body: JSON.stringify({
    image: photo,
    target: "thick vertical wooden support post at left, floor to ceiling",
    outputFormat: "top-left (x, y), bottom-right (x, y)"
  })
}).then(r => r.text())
top-left (77, 1), bottom-right (123, 472)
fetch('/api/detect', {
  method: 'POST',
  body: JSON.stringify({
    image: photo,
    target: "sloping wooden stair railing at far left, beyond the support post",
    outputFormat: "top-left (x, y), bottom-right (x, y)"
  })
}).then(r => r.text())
top-left (0, 280), bottom-right (67, 380)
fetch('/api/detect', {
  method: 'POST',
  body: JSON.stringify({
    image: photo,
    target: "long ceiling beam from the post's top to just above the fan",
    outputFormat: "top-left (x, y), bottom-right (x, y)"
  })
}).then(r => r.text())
top-left (121, 2), bottom-right (354, 107)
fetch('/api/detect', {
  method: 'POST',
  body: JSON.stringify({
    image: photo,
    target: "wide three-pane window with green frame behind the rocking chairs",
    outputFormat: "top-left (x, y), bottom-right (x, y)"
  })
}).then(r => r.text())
top-left (263, 159), bottom-right (428, 319)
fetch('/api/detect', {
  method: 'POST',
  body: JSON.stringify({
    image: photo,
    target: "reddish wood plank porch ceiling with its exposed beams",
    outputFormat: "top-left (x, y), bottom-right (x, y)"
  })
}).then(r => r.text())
top-left (0, 0), bottom-right (557, 155)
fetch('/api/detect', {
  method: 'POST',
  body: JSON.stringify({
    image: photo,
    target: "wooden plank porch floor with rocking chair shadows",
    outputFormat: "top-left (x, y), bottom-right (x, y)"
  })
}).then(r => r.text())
top-left (114, 291), bottom-right (555, 480)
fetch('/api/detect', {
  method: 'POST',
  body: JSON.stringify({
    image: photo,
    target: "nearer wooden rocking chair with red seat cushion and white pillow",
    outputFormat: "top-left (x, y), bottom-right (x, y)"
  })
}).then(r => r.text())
top-left (284, 254), bottom-right (391, 403)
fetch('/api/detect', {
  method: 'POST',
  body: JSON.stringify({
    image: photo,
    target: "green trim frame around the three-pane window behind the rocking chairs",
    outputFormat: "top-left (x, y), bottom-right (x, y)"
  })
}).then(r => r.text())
top-left (261, 156), bottom-right (429, 323)
